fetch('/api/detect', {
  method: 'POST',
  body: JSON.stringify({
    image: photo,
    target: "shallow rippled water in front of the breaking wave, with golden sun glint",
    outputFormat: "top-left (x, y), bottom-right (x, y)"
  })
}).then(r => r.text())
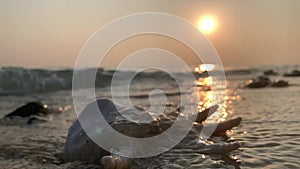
top-left (0, 66), bottom-right (300, 169)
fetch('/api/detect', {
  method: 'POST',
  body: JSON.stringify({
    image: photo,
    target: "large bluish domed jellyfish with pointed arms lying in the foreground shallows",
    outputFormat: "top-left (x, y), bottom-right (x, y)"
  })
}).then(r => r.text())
top-left (64, 99), bottom-right (241, 169)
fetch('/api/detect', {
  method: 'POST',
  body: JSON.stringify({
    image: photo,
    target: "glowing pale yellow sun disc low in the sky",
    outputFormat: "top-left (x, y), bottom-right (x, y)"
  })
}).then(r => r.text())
top-left (197, 15), bottom-right (218, 34)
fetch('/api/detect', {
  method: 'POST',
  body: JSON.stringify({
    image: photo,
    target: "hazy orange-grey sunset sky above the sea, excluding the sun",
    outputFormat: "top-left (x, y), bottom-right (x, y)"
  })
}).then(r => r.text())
top-left (0, 0), bottom-right (300, 67)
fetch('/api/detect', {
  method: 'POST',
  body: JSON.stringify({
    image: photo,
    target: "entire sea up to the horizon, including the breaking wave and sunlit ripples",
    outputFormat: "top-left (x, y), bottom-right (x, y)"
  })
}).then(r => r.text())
top-left (0, 65), bottom-right (300, 169)
